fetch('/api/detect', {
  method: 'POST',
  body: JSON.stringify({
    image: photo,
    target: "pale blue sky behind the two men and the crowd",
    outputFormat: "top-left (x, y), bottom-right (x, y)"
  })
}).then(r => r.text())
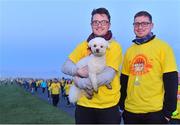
top-left (0, 0), bottom-right (180, 77)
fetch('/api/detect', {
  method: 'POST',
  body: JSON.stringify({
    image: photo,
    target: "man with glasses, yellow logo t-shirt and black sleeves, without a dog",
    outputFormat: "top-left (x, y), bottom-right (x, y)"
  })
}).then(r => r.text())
top-left (120, 11), bottom-right (178, 124)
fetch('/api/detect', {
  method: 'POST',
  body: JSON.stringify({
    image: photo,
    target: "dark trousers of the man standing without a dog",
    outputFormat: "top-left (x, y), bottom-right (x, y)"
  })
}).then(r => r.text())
top-left (123, 110), bottom-right (168, 124)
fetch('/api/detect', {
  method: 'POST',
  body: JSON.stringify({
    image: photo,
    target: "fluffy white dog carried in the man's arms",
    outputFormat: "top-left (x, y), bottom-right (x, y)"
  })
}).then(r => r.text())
top-left (69, 37), bottom-right (111, 103)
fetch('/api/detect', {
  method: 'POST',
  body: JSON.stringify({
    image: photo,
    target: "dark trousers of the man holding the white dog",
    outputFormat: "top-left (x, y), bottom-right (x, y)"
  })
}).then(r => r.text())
top-left (75, 105), bottom-right (121, 124)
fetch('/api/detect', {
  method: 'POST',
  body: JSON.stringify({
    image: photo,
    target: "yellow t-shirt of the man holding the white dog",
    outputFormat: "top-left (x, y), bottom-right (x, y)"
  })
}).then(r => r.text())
top-left (69, 40), bottom-right (122, 109)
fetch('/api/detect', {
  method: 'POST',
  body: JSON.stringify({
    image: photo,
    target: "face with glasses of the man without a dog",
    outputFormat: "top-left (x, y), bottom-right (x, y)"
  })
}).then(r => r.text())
top-left (133, 16), bottom-right (153, 38)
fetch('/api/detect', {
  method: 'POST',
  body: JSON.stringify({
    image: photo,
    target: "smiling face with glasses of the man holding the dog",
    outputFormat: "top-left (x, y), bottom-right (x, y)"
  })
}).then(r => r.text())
top-left (91, 14), bottom-right (110, 36)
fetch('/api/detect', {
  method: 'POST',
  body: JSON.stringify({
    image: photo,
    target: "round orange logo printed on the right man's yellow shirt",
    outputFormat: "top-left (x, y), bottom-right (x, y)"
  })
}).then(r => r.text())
top-left (130, 54), bottom-right (152, 75)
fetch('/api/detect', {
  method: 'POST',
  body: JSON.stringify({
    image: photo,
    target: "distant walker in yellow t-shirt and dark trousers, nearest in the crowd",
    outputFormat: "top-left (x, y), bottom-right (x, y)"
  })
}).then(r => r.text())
top-left (49, 79), bottom-right (60, 107)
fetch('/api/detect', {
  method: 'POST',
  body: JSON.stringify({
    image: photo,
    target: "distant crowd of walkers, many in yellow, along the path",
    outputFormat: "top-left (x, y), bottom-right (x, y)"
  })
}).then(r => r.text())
top-left (0, 77), bottom-right (74, 107)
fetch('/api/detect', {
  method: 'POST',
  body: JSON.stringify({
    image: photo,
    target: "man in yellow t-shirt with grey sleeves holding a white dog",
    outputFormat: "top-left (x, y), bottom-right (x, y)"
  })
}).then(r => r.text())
top-left (62, 8), bottom-right (122, 124)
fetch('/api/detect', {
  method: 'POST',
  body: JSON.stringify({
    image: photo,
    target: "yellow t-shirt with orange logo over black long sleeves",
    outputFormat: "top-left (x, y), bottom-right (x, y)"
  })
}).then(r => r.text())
top-left (122, 38), bottom-right (177, 113)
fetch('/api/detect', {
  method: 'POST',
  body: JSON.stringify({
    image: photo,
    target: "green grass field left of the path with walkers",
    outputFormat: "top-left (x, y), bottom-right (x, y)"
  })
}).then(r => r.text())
top-left (0, 85), bottom-right (75, 124)
